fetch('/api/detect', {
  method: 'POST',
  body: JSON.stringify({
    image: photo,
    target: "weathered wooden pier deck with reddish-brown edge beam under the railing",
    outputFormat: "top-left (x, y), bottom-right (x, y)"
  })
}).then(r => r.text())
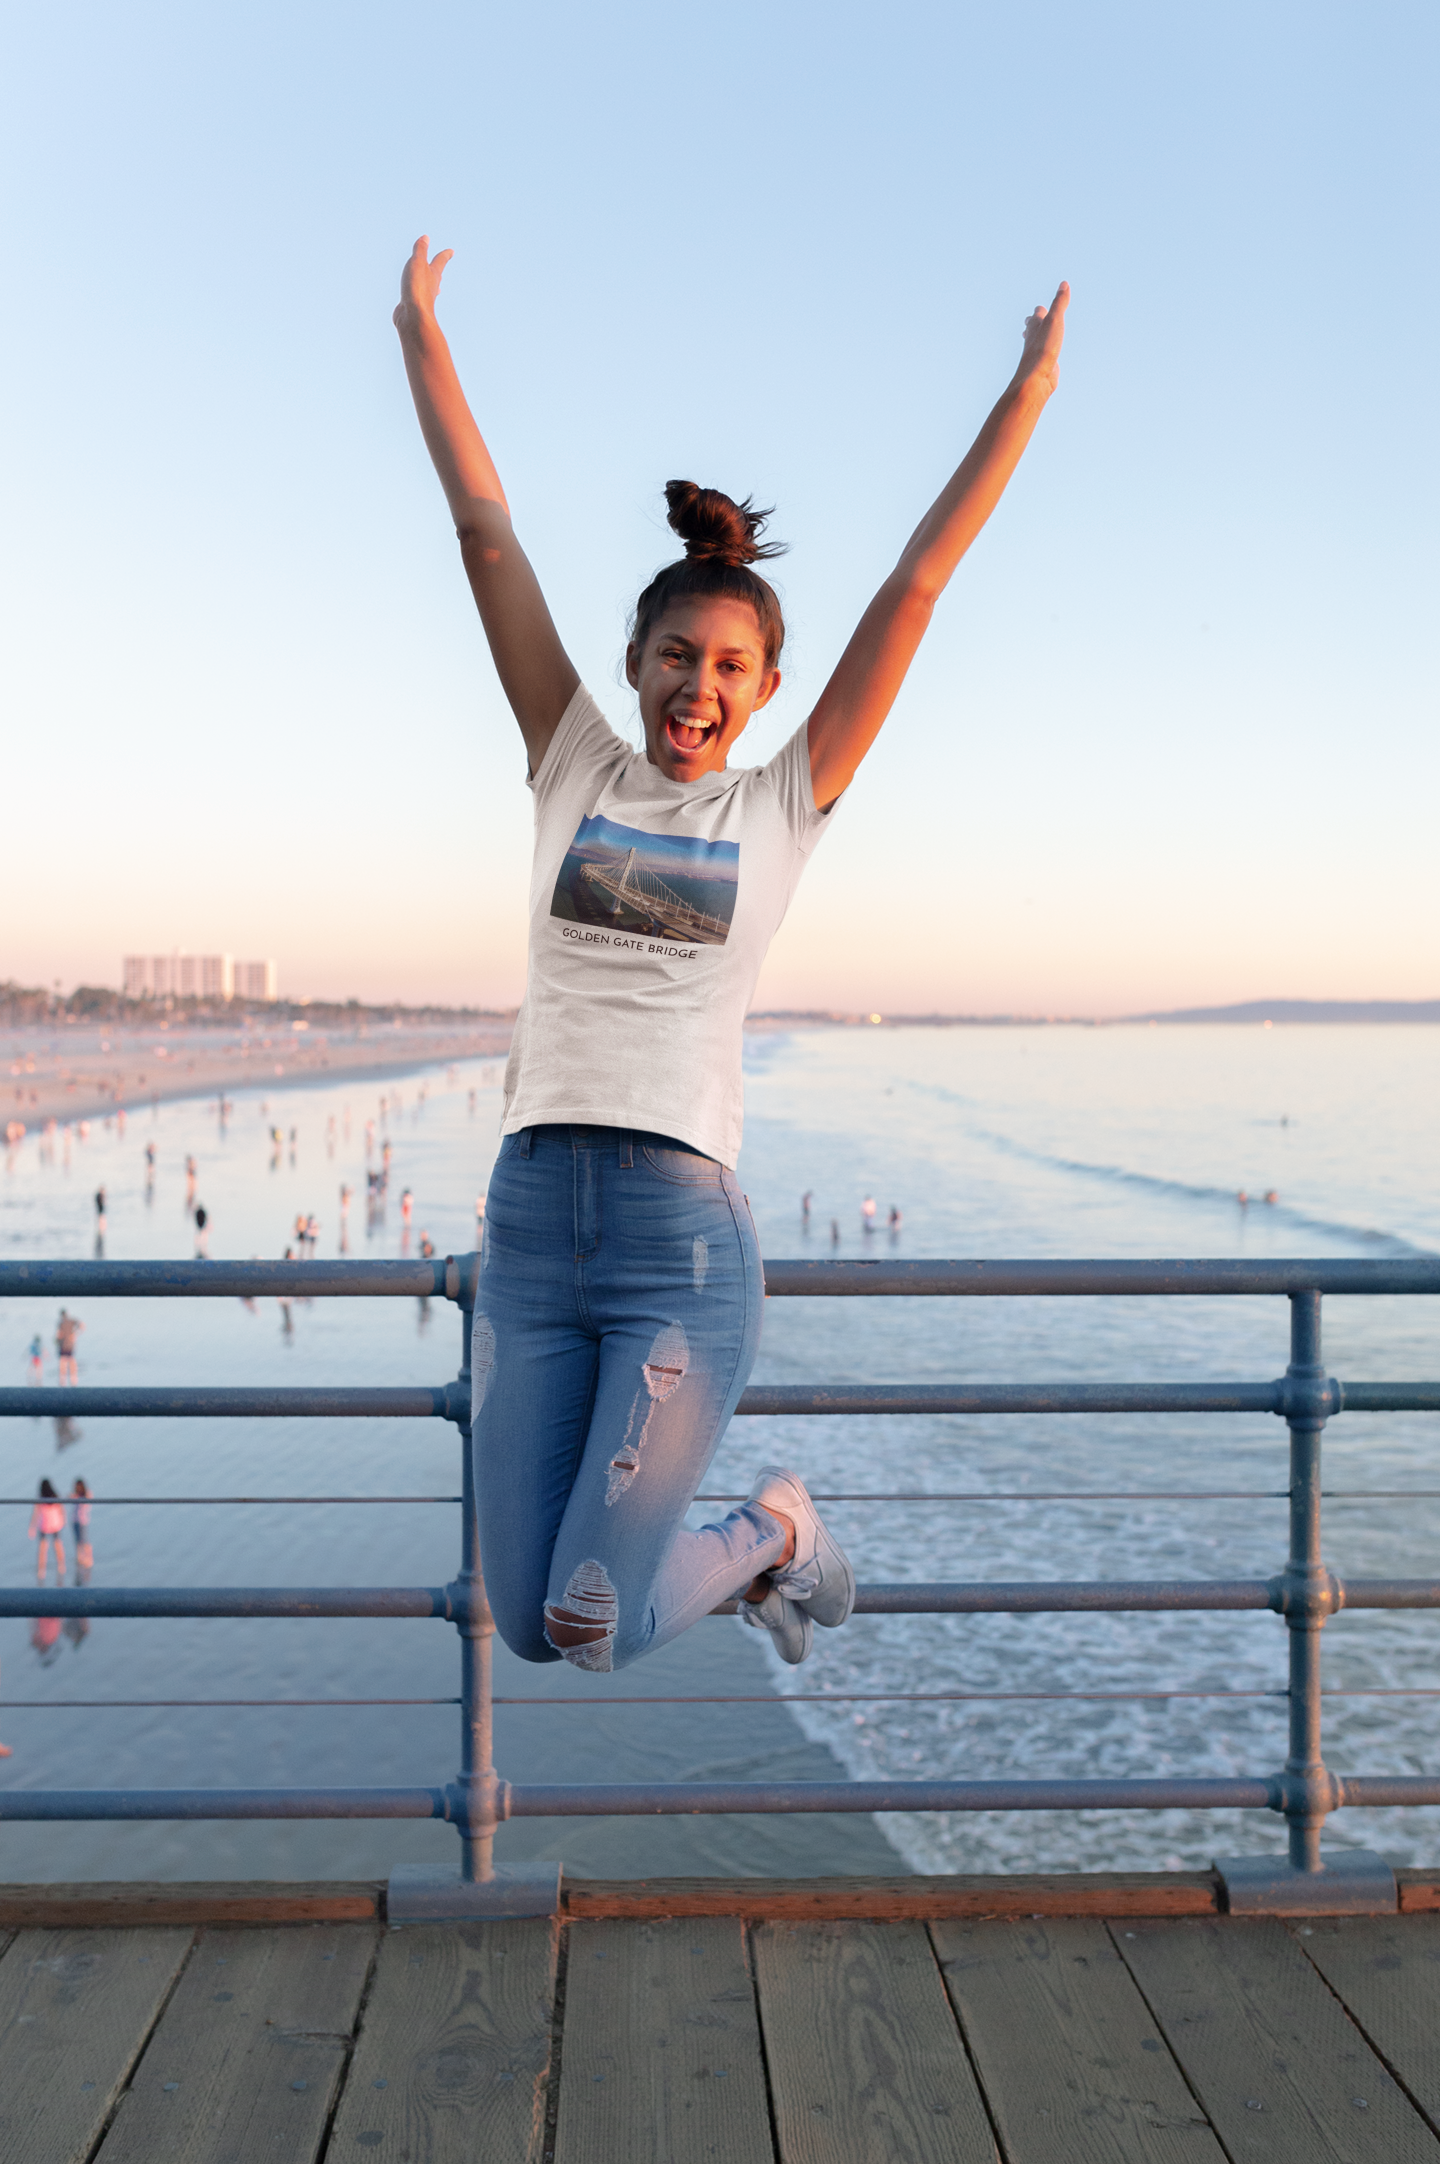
top-left (0, 1872), bottom-right (1440, 2164)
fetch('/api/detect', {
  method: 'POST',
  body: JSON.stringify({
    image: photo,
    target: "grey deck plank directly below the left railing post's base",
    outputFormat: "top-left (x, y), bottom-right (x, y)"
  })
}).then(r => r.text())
top-left (329, 1917), bottom-right (559, 2164)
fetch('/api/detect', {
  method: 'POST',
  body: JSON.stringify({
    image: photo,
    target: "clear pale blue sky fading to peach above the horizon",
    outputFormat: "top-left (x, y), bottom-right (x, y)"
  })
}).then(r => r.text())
top-left (0, 0), bottom-right (1440, 1013)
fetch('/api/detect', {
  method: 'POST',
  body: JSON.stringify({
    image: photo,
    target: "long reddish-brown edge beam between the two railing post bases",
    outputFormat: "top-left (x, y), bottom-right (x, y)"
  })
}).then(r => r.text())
top-left (561, 1872), bottom-right (1219, 1924)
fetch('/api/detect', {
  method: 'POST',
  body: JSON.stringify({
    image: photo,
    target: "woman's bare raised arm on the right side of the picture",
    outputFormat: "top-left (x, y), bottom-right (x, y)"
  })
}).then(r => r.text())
top-left (810, 286), bottom-right (1070, 805)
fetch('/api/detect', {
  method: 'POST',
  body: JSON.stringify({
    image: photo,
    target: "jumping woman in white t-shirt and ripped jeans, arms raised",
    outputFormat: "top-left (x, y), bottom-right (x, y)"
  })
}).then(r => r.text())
top-left (394, 238), bottom-right (1070, 1673)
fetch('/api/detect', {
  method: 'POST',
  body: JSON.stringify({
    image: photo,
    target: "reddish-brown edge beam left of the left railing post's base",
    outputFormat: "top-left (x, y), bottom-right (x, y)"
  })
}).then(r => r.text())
top-left (0, 1878), bottom-right (385, 1930)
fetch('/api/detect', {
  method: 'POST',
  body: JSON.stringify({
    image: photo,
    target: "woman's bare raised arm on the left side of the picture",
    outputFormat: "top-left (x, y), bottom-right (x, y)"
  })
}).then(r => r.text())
top-left (394, 234), bottom-right (580, 775)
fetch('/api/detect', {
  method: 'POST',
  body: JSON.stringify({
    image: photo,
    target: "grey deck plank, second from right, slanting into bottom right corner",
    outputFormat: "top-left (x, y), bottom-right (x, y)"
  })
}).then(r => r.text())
top-left (1111, 1915), bottom-right (1440, 2164)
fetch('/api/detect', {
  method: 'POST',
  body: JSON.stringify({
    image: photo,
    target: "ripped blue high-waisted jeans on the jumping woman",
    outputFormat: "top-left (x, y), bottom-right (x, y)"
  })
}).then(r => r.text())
top-left (470, 1127), bottom-right (786, 1673)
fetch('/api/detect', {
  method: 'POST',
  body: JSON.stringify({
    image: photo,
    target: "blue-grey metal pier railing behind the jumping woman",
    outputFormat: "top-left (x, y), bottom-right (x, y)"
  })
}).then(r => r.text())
top-left (0, 1255), bottom-right (1440, 1912)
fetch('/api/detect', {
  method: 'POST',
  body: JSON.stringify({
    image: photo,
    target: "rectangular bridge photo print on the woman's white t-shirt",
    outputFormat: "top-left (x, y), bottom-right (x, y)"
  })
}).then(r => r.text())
top-left (550, 814), bottom-right (741, 946)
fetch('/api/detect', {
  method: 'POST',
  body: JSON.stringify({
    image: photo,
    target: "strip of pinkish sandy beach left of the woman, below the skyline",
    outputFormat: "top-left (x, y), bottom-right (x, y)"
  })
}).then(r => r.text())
top-left (0, 1019), bottom-right (511, 1132)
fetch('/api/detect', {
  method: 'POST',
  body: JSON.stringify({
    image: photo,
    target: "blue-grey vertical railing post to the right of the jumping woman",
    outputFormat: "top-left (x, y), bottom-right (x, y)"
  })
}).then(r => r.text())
top-left (1284, 1292), bottom-right (1334, 1872)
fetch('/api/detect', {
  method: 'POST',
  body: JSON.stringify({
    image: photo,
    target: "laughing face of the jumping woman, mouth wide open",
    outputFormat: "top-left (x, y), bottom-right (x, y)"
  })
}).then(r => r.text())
top-left (626, 595), bottom-right (780, 781)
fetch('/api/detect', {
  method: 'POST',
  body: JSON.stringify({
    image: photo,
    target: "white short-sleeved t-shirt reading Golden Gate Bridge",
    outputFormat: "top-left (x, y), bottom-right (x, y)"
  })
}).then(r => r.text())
top-left (500, 686), bottom-right (834, 1169)
